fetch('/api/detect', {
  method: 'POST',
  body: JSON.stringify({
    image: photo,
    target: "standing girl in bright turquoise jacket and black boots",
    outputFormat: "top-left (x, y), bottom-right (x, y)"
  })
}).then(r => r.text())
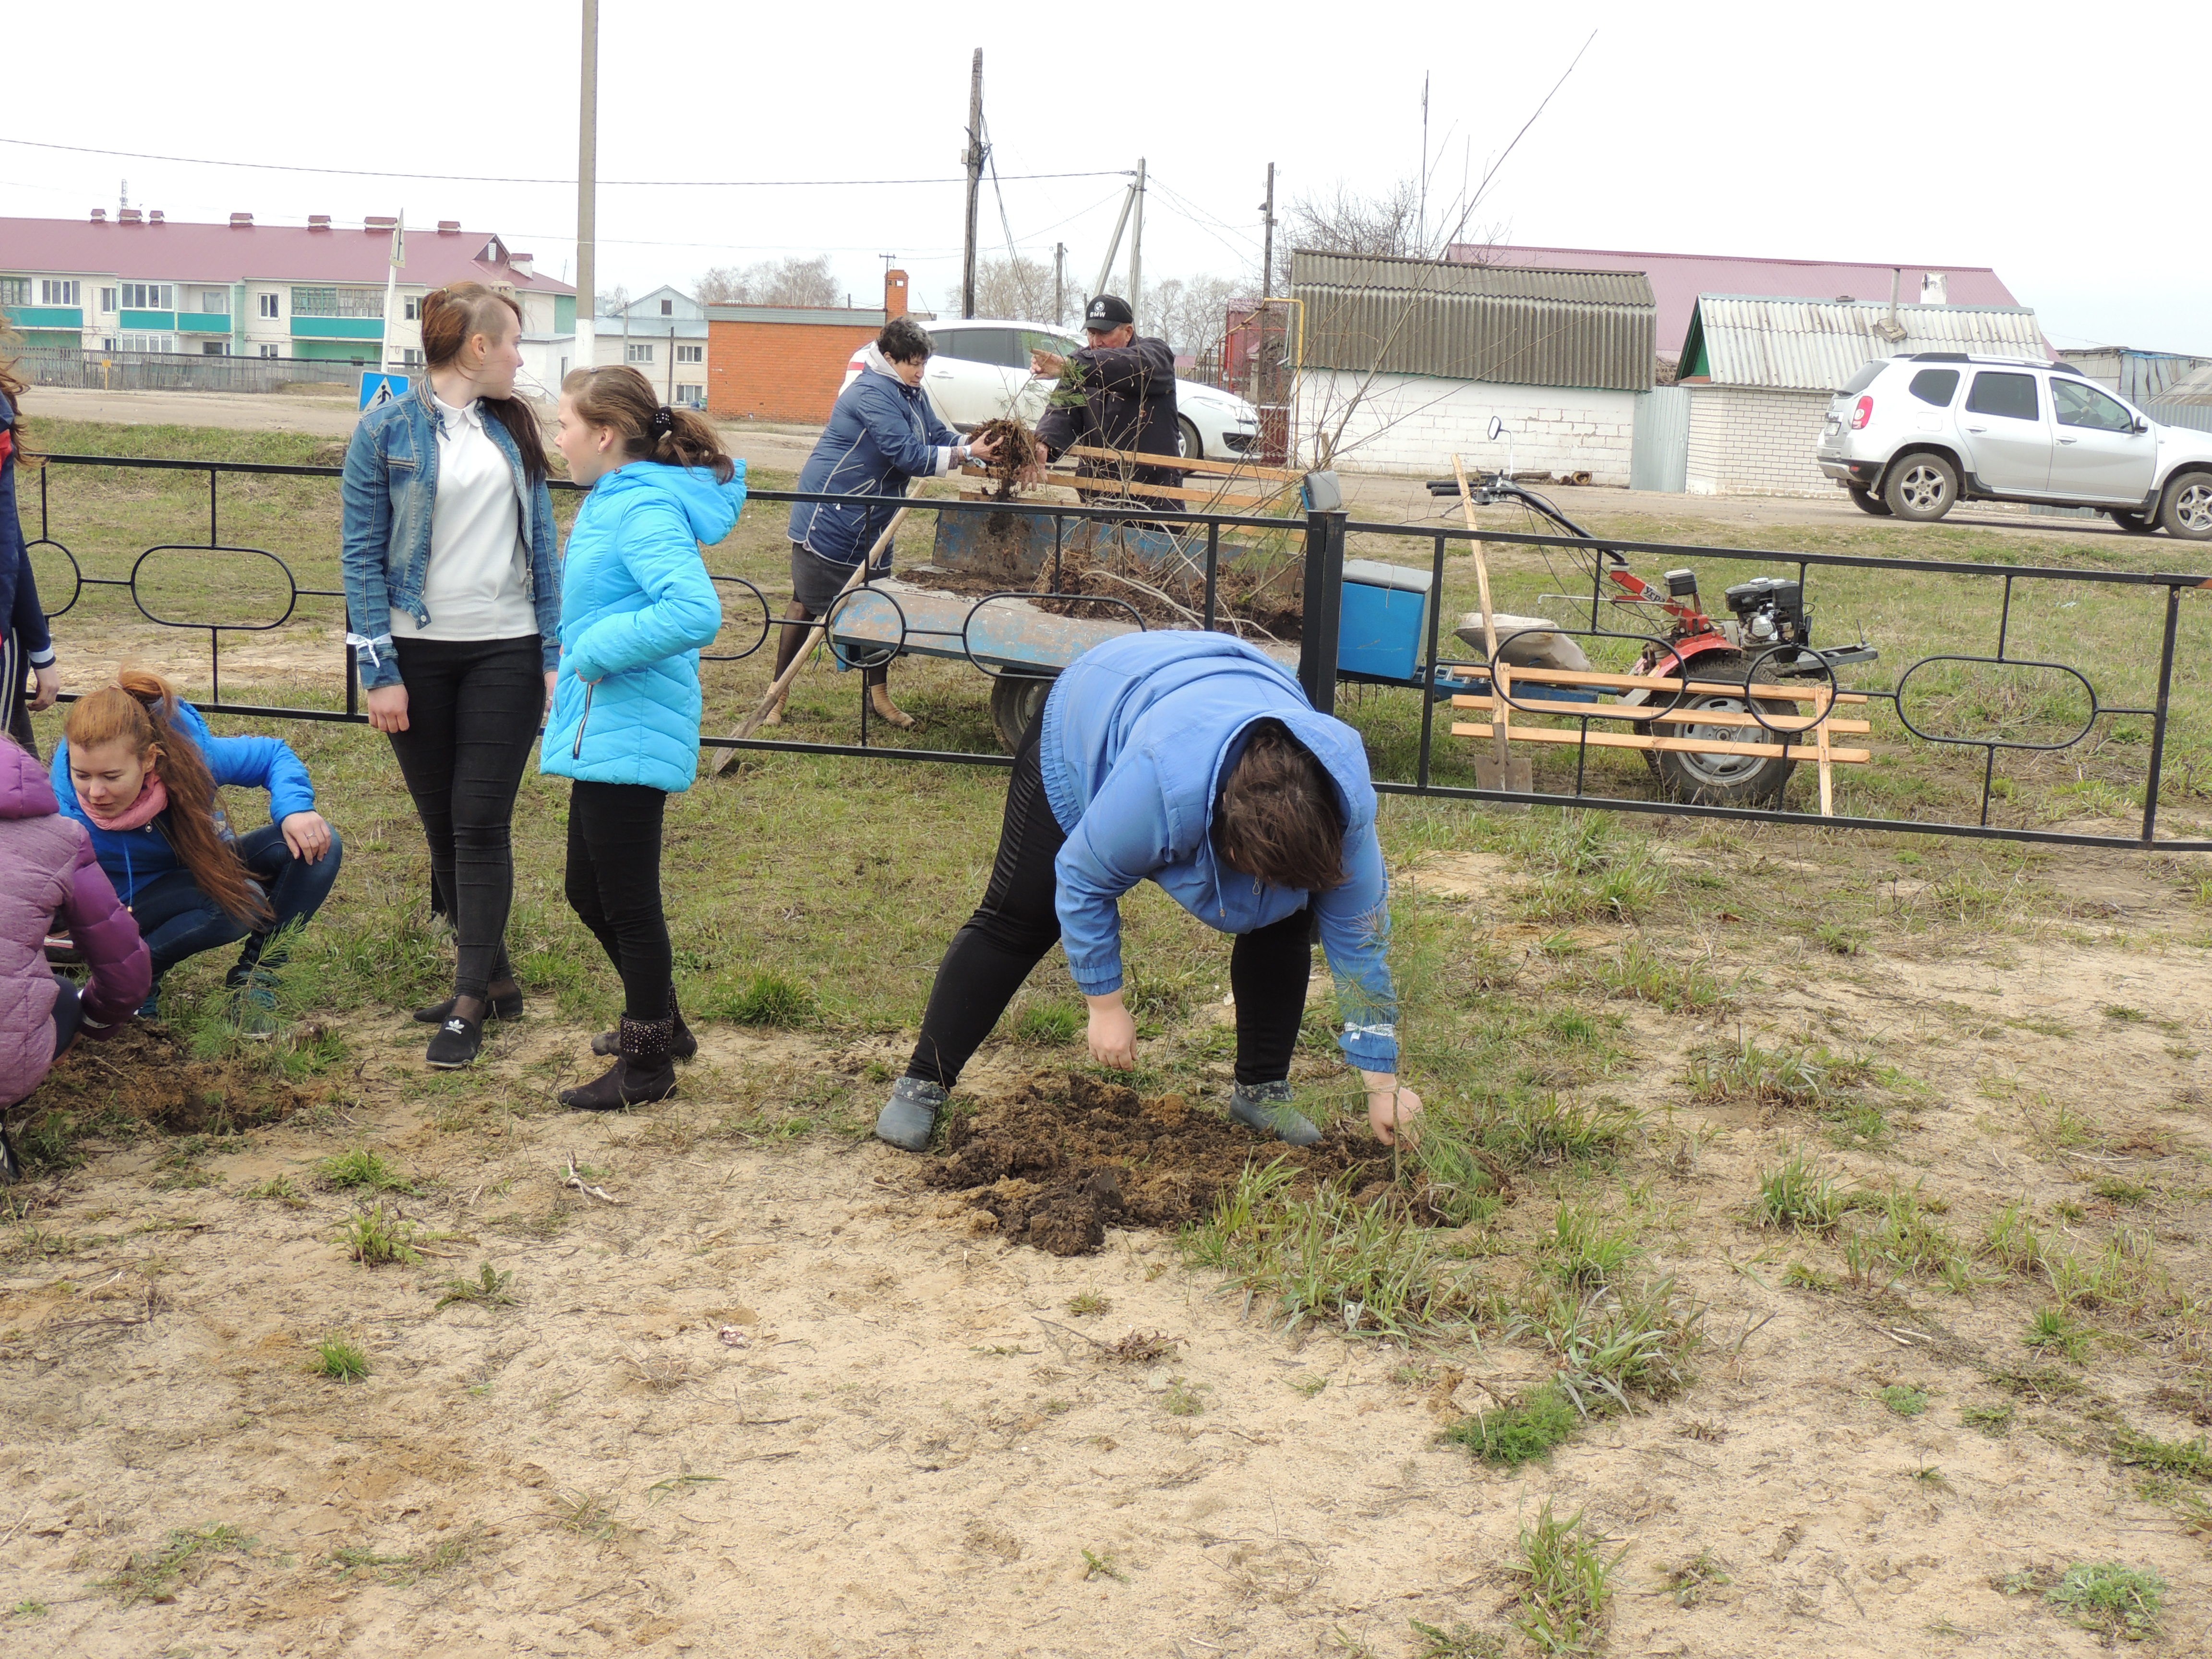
top-left (538, 365), bottom-right (745, 1113)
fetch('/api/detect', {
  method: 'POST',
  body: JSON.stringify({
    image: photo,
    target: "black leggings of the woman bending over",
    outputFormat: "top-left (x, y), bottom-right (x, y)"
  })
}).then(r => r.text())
top-left (907, 719), bottom-right (1314, 1088)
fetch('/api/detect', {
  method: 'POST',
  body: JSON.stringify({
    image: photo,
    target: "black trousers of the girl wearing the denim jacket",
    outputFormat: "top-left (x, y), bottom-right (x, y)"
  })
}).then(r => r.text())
top-left (392, 635), bottom-right (546, 998)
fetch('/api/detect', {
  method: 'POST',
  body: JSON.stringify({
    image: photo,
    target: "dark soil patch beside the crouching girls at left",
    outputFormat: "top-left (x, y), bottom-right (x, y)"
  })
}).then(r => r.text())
top-left (26, 1024), bottom-right (314, 1135)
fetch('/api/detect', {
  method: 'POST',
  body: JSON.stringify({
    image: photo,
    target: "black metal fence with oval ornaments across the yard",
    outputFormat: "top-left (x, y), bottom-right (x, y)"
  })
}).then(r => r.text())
top-left (26, 456), bottom-right (2212, 852)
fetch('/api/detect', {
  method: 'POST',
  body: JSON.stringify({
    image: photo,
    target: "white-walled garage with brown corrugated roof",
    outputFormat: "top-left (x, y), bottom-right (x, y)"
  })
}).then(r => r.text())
top-left (1289, 252), bottom-right (1655, 487)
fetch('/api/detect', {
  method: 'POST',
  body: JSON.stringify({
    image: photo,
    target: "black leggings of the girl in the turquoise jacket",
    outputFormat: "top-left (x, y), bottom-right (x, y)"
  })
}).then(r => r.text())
top-left (568, 779), bottom-right (674, 1020)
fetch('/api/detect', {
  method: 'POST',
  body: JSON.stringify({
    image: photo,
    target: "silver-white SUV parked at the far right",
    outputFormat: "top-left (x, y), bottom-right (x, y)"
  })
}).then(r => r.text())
top-left (1814, 352), bottom-right (2212, 542)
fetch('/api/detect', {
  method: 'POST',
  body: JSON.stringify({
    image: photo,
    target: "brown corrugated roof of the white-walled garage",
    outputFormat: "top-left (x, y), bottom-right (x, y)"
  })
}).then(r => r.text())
top-left (1292, 252), bottom-right (1657, 392)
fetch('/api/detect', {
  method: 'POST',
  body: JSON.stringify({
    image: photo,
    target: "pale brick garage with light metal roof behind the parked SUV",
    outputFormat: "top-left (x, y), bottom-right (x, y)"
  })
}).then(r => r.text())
top-left (1681, 294), bottom-right (2051, 495)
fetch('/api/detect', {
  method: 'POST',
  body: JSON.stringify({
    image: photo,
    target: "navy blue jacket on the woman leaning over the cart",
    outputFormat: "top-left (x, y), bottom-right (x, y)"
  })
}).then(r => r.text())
top-left (792, 345), bottom-right (960, 568)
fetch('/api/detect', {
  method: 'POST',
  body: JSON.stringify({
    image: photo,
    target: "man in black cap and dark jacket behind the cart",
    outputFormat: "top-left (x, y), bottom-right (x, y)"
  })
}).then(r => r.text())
top-left (1029, 294), bottom-right (1183, 511)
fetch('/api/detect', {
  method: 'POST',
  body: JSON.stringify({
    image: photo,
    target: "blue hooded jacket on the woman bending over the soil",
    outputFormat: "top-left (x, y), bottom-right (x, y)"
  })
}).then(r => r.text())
top-left (1037, 630), bottom-right (1398, 1070)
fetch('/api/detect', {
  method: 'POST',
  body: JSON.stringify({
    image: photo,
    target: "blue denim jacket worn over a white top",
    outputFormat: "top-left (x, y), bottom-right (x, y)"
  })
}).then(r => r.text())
top-left (341, 374), bottom-right (560, 690)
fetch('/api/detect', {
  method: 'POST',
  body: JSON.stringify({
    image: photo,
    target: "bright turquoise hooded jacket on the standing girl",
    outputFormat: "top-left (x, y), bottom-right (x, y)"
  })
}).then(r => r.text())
top-left (538, 460), bottom-right (745, 794)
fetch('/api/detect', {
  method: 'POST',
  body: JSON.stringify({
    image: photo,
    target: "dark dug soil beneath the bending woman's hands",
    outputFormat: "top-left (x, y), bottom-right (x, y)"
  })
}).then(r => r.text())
top-left (927, 1073), bottom-right (1391, 1256)
